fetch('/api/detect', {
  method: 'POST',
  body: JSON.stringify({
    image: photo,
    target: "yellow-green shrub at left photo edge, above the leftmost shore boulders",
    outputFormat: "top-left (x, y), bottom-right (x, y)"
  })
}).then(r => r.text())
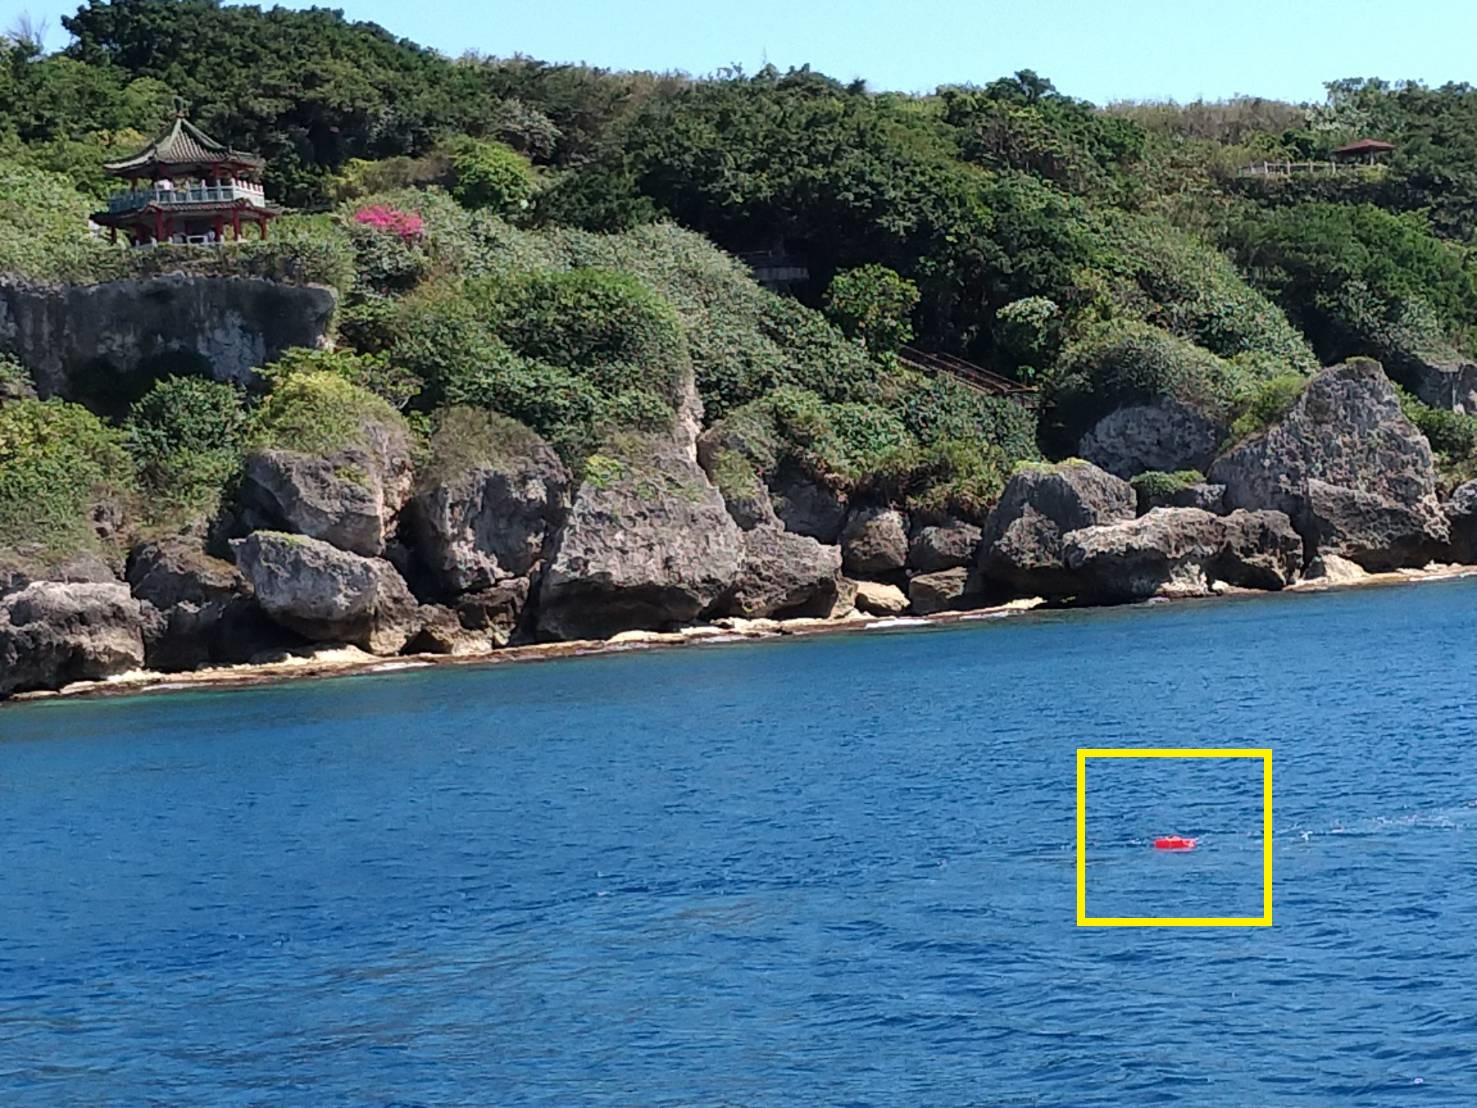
top-left (0, 399), bottom-right (133, 561)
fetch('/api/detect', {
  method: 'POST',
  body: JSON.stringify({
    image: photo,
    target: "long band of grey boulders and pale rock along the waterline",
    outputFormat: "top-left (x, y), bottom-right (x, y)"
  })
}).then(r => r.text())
top-left (0, 359), bottom-right (1477, 697)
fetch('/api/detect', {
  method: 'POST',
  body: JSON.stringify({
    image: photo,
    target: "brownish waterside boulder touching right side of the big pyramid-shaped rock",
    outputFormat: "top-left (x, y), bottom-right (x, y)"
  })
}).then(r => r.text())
top-left (719, 526), bottom-right (840, 619)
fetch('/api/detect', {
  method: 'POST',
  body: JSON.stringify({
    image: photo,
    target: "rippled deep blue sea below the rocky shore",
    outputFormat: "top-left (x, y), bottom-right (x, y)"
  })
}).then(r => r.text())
top-left (0, 582), bottom-right (1477, 1105)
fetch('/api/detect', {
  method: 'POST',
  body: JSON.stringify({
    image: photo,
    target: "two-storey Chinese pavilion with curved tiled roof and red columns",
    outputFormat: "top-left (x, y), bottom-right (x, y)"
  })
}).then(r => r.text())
top-left (93, 106), bottom-right (282, 245)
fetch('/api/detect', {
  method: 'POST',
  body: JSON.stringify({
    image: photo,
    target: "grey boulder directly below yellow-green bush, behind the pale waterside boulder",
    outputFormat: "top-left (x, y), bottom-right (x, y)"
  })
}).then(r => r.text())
top-left (236, 425), bottom-right (411, 558)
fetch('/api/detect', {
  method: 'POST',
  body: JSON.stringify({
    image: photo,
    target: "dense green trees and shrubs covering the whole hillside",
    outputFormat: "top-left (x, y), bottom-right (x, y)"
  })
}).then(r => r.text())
top-left (0, 0), bottom-right (1477, 558)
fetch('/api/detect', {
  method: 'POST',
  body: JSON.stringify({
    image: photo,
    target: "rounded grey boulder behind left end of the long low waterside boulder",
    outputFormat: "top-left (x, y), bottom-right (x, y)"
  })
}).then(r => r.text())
top-left (978, 461), bottom-right (1137, 595)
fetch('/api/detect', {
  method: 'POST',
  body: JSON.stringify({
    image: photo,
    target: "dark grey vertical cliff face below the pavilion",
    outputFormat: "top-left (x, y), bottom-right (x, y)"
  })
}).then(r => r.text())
top-left (0, 276), bottom-right (337, 399)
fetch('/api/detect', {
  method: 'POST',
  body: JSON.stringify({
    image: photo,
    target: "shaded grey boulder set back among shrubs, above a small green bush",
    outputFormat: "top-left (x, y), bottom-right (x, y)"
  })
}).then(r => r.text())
top-left (1077, 396), bottom-right (1226, 477)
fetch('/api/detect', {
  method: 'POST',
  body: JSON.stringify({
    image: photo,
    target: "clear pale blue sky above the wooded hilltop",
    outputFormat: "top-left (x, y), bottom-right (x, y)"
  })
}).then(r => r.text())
top-left (11, 0), bottom-right (1477, 103)
